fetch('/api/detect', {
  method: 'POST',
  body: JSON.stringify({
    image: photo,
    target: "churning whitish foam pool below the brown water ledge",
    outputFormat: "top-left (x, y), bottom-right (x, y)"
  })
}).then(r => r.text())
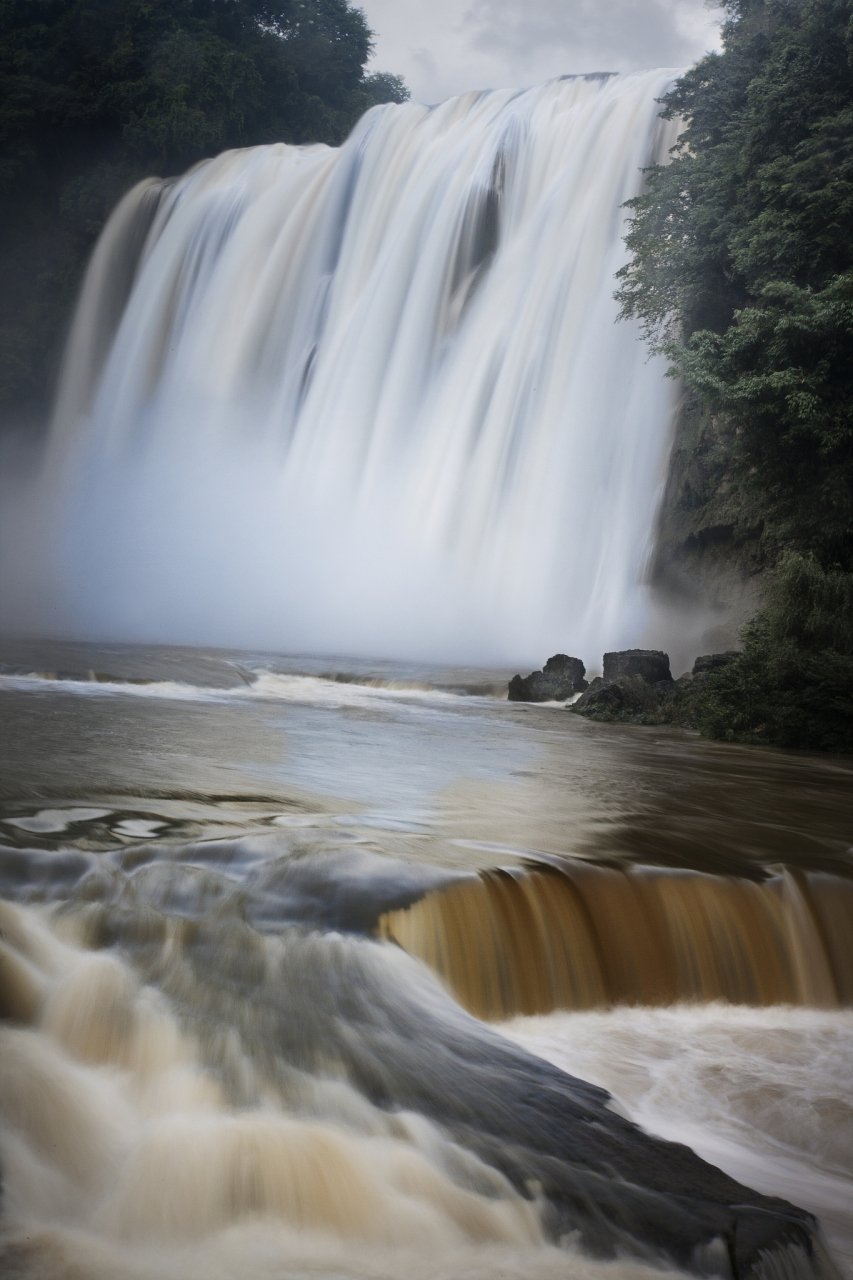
top-left (501, 1004), bottom-right (853, 1276)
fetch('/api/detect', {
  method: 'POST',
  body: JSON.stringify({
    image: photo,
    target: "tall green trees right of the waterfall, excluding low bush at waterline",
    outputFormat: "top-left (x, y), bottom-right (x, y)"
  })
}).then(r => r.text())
top-left (619, 0), bottom-right (853, 567)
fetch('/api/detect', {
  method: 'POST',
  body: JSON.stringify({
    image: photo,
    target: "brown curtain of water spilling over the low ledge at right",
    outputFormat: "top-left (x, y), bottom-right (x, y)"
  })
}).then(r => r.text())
top-left (379, 860), bottom-right (853, 1020)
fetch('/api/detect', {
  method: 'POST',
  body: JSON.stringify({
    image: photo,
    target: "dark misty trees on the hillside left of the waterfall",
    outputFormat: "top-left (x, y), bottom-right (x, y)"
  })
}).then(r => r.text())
top-left (0, 0), bottom-right (409, 413)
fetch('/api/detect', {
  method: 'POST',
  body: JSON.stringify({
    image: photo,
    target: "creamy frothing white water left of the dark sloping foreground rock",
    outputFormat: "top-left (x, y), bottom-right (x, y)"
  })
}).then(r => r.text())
top-left (0, 906), bottom-right (547, 1277)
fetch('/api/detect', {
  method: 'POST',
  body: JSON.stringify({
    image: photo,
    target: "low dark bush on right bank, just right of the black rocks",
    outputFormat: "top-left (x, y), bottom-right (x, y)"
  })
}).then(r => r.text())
top-left (690, 554), bottom-right (853, 751)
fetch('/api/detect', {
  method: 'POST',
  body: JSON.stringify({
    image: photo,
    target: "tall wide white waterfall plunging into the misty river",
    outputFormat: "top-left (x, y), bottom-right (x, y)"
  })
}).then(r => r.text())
top-left (5, 70), bottom-right (676, 662)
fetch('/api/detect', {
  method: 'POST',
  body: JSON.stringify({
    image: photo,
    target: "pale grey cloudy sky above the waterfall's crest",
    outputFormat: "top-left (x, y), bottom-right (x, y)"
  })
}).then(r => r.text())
top-left (360, 0), bottom-right (721, 102)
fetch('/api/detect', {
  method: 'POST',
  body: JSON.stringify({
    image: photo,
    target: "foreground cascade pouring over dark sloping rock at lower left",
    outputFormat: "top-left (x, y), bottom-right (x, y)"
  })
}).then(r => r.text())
top-left (0, 896), bottom-right (834, 1280)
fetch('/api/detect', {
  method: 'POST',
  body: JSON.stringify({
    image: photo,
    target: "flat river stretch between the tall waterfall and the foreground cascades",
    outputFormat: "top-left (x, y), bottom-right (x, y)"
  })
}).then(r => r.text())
top-left (0, 641), bottom-right (853, 876)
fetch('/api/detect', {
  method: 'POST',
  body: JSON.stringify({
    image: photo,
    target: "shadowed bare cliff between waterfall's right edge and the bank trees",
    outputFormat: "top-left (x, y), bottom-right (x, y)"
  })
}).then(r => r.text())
top-left (649, 392), bottom-right (781, 643)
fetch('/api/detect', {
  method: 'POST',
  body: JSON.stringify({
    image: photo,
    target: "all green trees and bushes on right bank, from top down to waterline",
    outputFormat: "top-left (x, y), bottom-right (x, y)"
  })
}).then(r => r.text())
top-left (619, 0), bottom-right (853, 751)
